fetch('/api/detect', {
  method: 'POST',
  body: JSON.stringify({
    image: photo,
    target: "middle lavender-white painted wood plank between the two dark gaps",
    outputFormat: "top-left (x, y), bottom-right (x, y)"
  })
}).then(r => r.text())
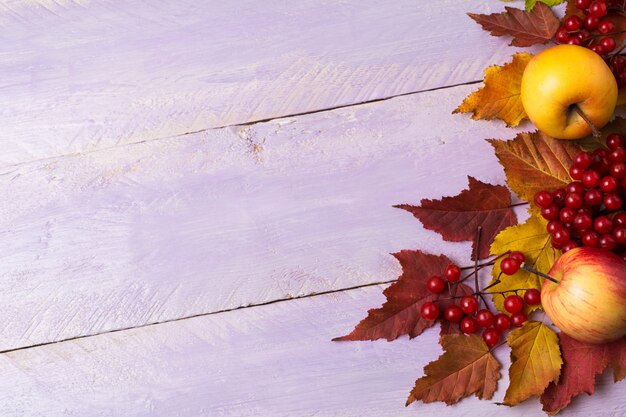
top-left (0, 86), bottom-right (528, 350)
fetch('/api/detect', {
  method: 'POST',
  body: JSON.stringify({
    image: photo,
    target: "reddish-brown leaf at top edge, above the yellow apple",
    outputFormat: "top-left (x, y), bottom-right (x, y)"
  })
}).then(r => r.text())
top-left (468, 3), bottom-right (559, 47)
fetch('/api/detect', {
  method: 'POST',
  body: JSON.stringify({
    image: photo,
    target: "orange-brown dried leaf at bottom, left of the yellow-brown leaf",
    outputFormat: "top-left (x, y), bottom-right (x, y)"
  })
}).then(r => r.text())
top-left (406, 334), bottom-right (500, 405)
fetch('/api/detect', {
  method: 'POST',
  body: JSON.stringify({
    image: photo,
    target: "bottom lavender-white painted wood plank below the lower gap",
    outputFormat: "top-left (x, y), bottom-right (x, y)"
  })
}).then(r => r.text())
top-left (0, 287), bottom-right (626, 417)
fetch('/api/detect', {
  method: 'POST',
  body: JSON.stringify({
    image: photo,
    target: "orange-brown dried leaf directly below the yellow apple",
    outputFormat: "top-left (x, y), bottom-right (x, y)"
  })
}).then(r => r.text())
top-left (487, 131), bottom-right (580, 201)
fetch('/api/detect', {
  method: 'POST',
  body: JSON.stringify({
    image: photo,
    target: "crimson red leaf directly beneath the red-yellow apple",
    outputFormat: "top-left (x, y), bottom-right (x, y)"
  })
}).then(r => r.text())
top-left (541, 333), bottom-right (626, 415)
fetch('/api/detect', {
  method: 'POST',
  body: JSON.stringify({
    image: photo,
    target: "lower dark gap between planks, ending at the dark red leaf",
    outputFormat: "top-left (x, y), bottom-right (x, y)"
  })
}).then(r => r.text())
top-left (0, 278), bottom-right (398, 354)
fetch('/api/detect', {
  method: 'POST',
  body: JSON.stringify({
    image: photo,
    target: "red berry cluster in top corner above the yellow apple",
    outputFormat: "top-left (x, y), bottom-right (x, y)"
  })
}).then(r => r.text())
top-left (554, 0), bottom-right (626, 87)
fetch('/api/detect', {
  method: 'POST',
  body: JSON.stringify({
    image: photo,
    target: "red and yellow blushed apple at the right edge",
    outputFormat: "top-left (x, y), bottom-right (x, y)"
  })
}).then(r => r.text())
top-left (541, 247), bottom-right (626, 343)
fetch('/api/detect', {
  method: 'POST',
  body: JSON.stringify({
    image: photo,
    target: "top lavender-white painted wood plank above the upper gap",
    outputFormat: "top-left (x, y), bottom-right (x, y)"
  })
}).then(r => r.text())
top-left (0, 0), bottom-right (513, 165)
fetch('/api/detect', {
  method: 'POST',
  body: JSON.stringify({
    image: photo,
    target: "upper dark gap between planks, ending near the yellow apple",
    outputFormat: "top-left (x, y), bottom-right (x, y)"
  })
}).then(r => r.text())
top-left (0, 79), bottom-right (483, 171)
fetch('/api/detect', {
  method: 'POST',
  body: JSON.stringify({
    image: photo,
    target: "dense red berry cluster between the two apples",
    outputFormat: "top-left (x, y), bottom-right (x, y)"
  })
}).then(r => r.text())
top-left (535, 133), bottom-right (626, 254)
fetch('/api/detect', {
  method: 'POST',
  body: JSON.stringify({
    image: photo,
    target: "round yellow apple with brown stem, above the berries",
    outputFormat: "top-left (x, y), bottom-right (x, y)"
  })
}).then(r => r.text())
top-left (521, 45), bottom-right (617, 139)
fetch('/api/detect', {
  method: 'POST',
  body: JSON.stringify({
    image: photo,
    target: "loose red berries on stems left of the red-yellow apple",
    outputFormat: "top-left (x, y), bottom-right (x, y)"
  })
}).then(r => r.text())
top-left (421, 252), bottom-right (541, 347)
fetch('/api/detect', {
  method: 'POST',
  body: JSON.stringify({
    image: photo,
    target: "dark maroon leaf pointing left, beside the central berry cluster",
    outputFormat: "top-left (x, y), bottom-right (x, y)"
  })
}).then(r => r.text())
top-left (395, 177), bottom-right (517, 259)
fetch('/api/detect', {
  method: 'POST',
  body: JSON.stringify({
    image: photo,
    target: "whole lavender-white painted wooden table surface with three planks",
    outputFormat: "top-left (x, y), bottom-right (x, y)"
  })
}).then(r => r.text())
top-left (0, 0), bottom-right (626, 417)
